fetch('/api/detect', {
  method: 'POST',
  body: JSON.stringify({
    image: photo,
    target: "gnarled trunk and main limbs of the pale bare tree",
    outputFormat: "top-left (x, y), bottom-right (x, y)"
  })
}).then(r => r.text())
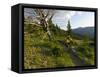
top-left (35, 9), bottom-right (54, 40)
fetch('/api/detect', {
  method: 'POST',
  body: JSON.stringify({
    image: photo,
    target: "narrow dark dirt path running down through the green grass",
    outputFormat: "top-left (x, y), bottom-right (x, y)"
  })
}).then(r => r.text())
top-left (59, 41), bottom-right (85, 66)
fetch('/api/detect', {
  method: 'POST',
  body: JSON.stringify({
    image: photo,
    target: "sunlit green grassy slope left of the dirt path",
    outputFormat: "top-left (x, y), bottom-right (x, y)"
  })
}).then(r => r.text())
top-left (24, 31), bottom-right (74, 69)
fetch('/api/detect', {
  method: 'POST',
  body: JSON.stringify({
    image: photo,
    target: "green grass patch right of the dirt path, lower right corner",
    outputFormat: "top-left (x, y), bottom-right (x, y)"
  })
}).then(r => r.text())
top-left (77, 46), bottom-right (94, 65)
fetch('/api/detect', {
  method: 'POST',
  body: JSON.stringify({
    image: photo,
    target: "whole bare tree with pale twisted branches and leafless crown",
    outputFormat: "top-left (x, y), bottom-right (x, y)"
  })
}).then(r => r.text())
top-left (24, 9), bottom-right (54, 40)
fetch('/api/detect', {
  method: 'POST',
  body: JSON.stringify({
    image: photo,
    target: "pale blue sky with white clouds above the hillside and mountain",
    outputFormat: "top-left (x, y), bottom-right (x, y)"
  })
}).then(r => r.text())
top-left (24, 8), bottom-right (95, 30)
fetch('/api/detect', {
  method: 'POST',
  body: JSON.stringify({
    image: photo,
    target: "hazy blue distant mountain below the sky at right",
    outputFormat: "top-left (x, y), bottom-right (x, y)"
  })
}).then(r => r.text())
top-left (72, 27), bottom-right (94, 38)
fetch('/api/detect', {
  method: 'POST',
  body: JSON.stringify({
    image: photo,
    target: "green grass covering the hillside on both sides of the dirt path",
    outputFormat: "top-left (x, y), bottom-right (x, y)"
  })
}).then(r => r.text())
top-left (24, 25), bottom-right (94, 69)
